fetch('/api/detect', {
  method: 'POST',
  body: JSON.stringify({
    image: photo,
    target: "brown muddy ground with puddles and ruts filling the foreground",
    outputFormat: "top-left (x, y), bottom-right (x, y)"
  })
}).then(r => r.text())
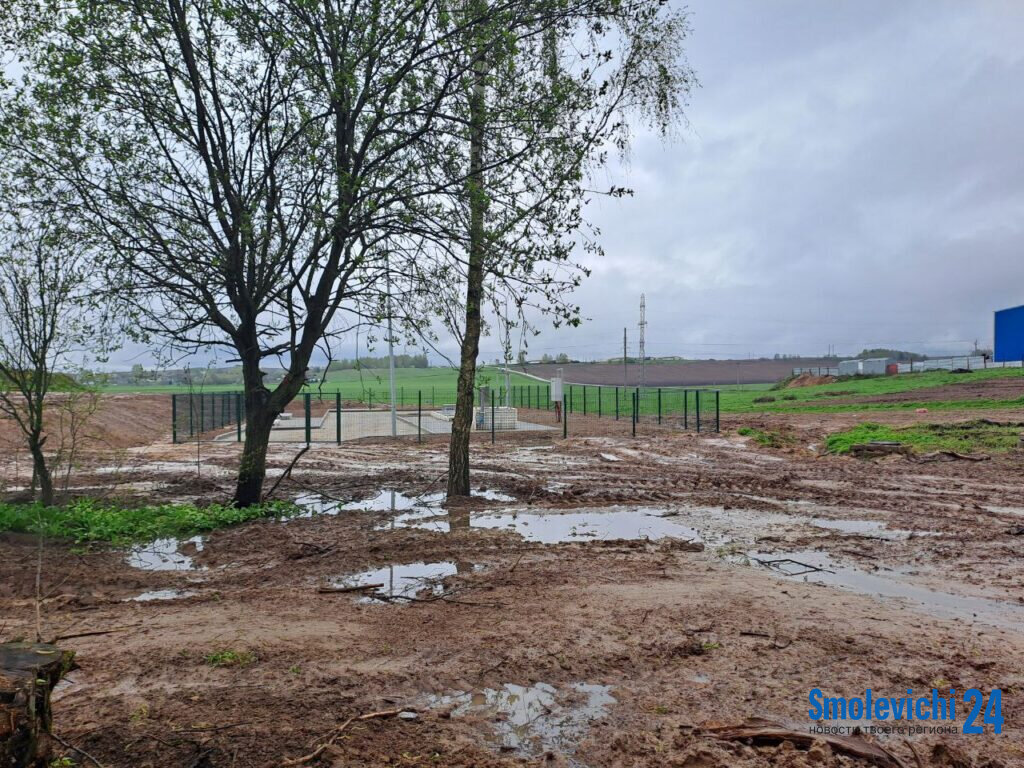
top-left (0, 397), bottom-right (1024, 768)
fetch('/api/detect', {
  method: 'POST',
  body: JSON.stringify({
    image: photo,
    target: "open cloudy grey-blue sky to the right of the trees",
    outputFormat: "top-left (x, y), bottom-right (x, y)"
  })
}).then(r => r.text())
top-left (105, 0), bottom-right (1024, 370)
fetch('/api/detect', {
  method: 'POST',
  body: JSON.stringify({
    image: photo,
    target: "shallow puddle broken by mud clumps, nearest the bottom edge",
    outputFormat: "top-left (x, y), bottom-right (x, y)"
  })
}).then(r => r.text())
top-left (428, 683), bottom-right (615, 766)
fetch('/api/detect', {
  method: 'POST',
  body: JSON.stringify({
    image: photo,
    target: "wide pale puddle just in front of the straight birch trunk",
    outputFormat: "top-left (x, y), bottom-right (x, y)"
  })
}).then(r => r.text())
top-left (381, 507), bottom-right (700, 544)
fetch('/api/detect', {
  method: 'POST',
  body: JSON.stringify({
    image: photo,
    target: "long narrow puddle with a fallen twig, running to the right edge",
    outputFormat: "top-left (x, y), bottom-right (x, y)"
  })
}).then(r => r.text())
top-left (746, 552), bottom-right (1024, 629)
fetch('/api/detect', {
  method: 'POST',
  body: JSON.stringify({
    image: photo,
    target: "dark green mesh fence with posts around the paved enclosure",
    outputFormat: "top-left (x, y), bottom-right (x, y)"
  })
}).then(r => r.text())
top-left (171, 384), bottom-right (720, 444)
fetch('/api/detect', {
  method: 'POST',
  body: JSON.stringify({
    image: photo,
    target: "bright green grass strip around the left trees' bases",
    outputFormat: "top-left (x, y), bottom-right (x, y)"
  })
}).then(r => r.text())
top-left (0, 500), bottom-right (301, 546)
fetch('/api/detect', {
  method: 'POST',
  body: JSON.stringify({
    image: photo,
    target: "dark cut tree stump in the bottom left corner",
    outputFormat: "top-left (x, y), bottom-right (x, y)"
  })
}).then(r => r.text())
top-left (0, 643), bottom-right (75, 768)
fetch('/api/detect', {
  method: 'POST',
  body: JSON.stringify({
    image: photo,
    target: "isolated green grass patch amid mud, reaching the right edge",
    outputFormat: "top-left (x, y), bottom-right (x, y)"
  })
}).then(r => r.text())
top-left (825, 421), bottom-right (1021, 454)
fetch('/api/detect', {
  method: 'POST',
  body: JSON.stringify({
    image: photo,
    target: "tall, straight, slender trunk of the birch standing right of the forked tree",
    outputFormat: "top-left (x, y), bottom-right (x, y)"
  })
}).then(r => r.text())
top-left (447, 20), bottom-right (487, 499)
